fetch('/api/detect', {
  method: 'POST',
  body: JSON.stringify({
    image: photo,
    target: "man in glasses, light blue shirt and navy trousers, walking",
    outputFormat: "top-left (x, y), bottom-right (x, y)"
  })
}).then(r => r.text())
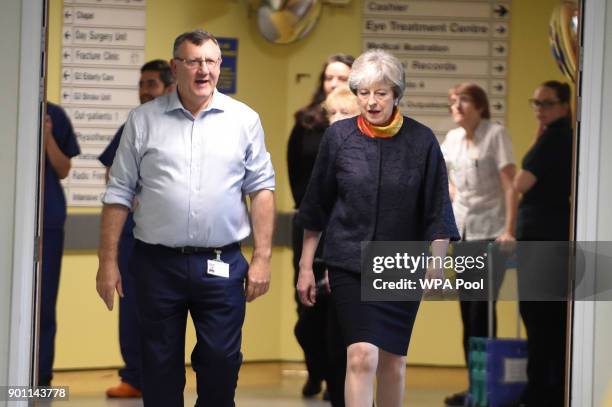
top-left (96, 30), bottom-right (274, 407)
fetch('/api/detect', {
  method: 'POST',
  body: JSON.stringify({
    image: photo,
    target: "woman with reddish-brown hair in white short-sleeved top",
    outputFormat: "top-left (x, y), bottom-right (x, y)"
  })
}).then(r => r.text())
top-left (442, 83), bottom-right (516, 406)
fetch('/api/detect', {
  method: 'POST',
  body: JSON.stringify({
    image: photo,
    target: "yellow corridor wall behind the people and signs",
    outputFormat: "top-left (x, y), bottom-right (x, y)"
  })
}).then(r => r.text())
top-left (48, 0), bottom-right (563, 368)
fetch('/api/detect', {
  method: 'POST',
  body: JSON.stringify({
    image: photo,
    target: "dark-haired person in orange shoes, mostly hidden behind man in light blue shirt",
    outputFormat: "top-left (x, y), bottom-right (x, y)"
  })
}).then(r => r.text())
top-left (98, 59), bottom-right (174, 398)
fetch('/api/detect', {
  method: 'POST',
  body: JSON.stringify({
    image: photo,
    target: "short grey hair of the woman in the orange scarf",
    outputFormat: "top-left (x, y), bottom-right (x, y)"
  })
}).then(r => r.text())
top-left (349, 49), bottom-right (406, 105)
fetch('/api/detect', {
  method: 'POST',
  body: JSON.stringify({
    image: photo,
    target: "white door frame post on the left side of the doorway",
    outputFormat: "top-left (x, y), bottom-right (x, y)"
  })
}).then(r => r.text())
top-left (8, 0), bottom-right (47, 396)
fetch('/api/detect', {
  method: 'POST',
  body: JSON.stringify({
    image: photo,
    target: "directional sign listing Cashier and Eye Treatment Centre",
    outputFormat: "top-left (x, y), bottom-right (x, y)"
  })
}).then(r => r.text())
top-left (362, 0), bottom-right (512, 137)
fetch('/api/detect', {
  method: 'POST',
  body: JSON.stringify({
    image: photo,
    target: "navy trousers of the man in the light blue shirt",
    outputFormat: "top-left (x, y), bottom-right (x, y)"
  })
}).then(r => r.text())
top-left (132, 240), bottom-right (248, 407)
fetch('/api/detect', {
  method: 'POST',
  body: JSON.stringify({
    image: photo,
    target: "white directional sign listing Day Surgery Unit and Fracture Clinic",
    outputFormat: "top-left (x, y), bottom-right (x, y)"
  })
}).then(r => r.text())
top-left (59, 0), bottom-right (146, 206)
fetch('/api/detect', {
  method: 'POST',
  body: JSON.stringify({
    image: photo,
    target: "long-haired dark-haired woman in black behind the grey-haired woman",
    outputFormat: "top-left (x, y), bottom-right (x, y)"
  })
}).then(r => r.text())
top-left (287, 54), bottom-right (354, 406)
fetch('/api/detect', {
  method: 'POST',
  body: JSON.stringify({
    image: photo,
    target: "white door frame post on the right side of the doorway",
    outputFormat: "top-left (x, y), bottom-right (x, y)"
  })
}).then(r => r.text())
top-left (571, 0), bottom-right (610, 407)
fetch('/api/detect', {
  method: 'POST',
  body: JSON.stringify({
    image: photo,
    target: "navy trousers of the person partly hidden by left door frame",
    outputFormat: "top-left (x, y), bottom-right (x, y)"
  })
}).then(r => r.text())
top-left (38, 229), bottom-right (64, 386)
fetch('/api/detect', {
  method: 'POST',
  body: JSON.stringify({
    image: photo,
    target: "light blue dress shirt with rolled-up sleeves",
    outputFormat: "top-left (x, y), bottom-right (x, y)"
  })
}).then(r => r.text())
top-left (102, 90), bottom-right (274, 247)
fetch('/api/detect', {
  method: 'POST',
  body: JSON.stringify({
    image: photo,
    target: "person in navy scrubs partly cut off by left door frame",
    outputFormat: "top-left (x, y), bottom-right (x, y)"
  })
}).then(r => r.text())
top-left (38, 102), bottom-right (81, 386)
